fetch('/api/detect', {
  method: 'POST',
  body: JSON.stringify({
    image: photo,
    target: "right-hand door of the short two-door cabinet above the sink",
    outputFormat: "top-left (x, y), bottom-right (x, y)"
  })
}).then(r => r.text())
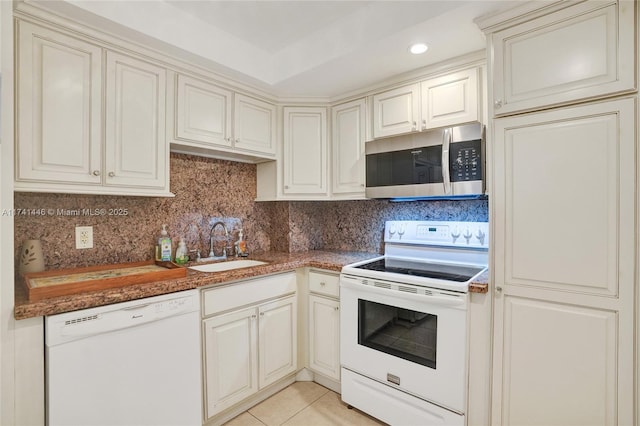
top-left (234, 94), bottom-right (276, 155)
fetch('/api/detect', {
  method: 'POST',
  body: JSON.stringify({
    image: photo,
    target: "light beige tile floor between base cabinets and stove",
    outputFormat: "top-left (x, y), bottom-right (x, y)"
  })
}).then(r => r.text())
top-left (225, 382), bottom-right (385, 426)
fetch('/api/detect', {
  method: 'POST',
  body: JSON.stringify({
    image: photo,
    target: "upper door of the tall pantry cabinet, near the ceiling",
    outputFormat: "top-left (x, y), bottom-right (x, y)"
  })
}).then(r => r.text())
top-left (492, 1), bottom-right (636, 115)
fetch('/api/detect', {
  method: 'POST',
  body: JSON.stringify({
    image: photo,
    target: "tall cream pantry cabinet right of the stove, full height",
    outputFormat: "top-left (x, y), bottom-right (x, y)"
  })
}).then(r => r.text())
top-left (478, 1), bottom-right (639, 425)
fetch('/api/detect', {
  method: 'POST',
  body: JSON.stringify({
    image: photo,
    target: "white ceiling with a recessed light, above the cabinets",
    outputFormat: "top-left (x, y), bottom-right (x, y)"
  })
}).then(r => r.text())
top-left (32, 0), bottom-right (515, 97)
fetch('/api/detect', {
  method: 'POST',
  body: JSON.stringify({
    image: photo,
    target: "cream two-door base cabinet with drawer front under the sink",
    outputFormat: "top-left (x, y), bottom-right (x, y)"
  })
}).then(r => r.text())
top-left (202, 272), bottom-right (298, 419)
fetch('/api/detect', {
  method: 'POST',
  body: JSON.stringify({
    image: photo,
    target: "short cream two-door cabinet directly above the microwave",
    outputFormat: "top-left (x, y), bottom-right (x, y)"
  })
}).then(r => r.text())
top-left (372, 68), bottom-right (480, 138)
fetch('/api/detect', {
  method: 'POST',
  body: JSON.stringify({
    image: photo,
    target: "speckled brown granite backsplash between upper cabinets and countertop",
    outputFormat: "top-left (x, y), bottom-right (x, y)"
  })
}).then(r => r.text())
top-left (14, 153), bottom-right (488, 269)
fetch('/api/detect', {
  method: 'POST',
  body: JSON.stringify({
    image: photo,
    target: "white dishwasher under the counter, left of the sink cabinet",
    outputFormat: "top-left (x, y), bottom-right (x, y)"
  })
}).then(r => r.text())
top-left (45, 290), bottom-right (202, 426)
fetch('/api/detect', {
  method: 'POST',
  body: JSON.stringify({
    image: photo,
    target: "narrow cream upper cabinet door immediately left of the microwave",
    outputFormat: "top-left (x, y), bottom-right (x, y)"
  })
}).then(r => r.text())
top-left (331, 99), bottom-right (365, 196)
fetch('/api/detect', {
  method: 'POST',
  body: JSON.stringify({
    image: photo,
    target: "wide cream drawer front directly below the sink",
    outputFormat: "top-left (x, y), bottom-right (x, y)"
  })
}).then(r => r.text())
top-left (202, 272), bottom-right (296, 317)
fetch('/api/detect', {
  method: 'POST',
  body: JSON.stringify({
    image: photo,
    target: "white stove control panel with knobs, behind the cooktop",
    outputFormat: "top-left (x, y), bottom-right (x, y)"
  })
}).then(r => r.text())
top-left (384, 220), bottom-right (489, 249)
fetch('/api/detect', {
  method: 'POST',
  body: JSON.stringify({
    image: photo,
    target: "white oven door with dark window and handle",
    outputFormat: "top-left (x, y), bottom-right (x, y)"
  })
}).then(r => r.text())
top-left (340, 274), bottom-right (468, 414)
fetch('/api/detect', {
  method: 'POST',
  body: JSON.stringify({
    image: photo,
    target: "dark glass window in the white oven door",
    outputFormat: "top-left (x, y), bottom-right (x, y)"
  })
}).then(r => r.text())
top-left (358, 299), bottom-right (438, 369)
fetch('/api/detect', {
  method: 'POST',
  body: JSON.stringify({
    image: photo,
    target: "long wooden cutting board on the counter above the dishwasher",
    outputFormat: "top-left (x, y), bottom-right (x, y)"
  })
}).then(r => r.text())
top-left (23, 260), bottom-right (187, 302)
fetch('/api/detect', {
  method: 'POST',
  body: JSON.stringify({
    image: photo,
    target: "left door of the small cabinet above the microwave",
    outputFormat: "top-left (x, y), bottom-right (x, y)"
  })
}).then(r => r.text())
top-left (373, 83), bottom-right (420, 138)
